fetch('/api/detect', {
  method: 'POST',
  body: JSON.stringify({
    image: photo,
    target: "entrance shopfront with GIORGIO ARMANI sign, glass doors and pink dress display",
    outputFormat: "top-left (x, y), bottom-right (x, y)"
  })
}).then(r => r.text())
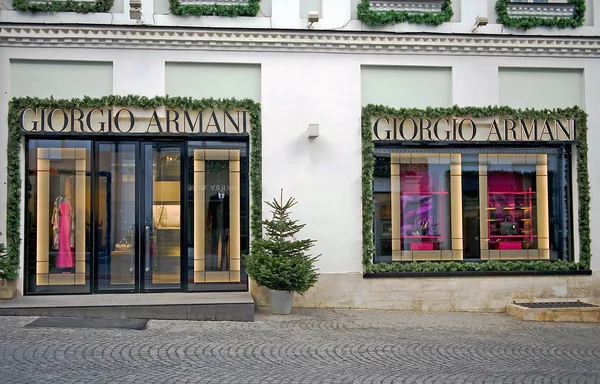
top-left (19, 103), bottom-right (252, 294)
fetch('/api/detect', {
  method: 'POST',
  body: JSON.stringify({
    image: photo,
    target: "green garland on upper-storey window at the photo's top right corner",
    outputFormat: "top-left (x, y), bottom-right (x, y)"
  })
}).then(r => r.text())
top-left (496, 0), bottom-right (585, 30)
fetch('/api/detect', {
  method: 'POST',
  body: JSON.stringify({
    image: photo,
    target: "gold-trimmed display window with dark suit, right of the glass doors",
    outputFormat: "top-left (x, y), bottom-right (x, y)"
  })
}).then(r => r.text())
top-left (188, 142), bottom-right (249, 290)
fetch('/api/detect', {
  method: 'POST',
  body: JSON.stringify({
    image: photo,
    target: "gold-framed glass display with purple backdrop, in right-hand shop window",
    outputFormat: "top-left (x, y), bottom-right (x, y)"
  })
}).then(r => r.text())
top-left (376, 153), bottom-right (462, 261)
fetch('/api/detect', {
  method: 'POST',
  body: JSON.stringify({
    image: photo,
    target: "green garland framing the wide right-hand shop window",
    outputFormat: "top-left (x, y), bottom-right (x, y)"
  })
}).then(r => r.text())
top-left (361, 104), bottom-right (592, 273)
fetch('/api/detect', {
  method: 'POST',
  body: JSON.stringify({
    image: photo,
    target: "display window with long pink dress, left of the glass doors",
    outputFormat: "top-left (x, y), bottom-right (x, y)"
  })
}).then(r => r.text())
top-left (26, 140), bottom-right (91, 292)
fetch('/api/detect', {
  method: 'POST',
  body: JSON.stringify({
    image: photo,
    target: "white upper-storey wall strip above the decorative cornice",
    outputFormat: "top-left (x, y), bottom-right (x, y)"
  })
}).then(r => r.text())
top-left (0, 0), bottom-right (600, 36)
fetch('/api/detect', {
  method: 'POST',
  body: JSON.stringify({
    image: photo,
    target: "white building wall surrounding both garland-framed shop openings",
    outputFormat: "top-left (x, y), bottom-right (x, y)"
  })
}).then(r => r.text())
top-left (0, 0), bottom-right (600, 309)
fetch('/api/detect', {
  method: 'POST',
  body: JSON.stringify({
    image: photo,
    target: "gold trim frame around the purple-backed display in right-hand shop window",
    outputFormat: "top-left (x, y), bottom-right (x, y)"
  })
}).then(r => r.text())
top-left (390, 153), bottom-right (463, 261)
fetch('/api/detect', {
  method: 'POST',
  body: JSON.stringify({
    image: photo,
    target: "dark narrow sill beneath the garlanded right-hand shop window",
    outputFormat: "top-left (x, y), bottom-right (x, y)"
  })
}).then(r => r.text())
top-left (363, 269), bottom-right (592, 279)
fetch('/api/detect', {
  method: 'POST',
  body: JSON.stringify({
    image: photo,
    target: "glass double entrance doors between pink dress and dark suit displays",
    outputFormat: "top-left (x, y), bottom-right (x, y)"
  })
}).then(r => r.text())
top-left (95, 142), bottom-right (182, 292)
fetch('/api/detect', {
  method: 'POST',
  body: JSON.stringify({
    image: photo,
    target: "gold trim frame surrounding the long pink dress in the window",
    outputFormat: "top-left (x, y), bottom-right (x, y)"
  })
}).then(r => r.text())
top-left (36, 148), bottom-right (87, 285)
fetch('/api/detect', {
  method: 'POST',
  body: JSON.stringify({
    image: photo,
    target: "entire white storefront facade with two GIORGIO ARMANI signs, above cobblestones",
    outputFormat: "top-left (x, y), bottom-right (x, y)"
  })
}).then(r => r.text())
top-left (0, 0), bottom-right (600, 311)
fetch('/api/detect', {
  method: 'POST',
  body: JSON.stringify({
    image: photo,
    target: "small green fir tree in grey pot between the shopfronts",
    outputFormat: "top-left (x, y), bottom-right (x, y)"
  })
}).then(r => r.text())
top-left (244, 190), bottom-right (319, 315)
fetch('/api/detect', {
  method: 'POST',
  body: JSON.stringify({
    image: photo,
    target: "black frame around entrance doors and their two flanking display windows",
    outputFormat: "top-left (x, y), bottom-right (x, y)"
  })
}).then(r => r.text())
top-left (23, 133), bottom-right (250, 296)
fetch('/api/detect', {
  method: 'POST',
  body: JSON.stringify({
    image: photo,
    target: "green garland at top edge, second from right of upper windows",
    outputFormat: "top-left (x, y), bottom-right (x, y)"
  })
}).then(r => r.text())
top-left (357, 0), bottom-right (454, 26)
